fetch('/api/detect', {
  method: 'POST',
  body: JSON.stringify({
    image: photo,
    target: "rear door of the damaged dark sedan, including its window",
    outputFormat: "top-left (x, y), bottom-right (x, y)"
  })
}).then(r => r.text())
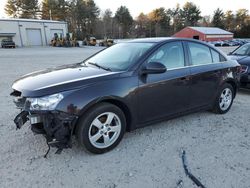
top-left (186, 42), bottom-right (222, 108)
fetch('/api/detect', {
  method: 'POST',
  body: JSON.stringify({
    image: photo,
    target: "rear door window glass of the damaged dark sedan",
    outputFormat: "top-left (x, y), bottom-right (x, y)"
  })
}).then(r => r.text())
top-left (188, 42), bottom-right (213, 65)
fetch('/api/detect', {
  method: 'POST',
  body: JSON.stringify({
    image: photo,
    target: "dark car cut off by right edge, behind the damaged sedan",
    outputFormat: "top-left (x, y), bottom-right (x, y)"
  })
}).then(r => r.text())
top-left (228, 43), bottom-right (250, 88)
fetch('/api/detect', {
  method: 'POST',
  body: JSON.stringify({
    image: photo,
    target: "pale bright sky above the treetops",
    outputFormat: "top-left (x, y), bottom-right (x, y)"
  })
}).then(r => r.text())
top-left (0, 0), bottom-right (250, 18)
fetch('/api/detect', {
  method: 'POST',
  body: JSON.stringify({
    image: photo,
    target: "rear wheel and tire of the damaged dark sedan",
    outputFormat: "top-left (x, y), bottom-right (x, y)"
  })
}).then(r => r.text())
top-left (213, 83), bottom-right (235, 114)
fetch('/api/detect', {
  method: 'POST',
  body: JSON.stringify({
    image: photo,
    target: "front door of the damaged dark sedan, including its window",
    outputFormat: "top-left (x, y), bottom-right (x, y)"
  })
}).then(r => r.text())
top-left (138, 41), bottom-right (190, 123)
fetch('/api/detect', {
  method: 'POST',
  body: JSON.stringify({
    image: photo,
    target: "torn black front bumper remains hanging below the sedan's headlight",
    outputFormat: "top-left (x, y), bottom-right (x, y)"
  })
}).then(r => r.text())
top-left (14, 111), bottom-right (78, 156)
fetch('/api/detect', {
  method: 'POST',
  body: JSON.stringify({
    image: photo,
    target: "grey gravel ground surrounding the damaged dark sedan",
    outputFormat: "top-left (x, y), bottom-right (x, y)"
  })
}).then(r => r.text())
top-left (0, 47), bottom-right (250, 188)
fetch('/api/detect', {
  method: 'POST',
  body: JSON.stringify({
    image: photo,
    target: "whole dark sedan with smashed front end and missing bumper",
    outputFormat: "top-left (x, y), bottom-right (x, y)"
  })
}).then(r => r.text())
top-left (11, 38), bottom-right (240, 154)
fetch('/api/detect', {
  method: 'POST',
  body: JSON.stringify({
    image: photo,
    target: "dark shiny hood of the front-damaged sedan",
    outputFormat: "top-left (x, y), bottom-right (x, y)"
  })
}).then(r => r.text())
top-left (12, 64), bottom-right (122, 97)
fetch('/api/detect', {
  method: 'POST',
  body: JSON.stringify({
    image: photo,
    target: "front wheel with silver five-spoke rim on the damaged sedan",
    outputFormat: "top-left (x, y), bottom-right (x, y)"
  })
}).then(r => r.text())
top-left (76, 103), bottom-right (126, 154)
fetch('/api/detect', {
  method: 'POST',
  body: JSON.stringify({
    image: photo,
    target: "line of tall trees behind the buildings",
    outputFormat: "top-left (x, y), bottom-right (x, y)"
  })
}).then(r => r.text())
top-left (5, 0), bottom-right (250, 40)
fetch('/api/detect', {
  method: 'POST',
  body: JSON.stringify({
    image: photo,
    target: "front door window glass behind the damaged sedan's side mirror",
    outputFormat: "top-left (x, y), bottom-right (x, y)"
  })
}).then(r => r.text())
top-left (147, 42), bottom-right (185, 69)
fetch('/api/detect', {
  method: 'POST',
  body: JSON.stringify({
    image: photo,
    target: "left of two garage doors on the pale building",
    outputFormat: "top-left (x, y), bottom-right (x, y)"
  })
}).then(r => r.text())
top-left (26, 29), bottom-right (42, 46)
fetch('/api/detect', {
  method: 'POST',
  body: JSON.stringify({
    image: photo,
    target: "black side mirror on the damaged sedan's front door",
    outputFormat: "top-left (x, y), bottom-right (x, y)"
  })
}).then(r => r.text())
top-left (141, 62), bottom-right (167, 74)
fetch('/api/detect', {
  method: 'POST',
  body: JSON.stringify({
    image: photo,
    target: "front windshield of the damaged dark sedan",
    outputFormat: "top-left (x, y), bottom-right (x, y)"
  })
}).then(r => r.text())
top-left (84, 43), bottom-right (154, 71)
